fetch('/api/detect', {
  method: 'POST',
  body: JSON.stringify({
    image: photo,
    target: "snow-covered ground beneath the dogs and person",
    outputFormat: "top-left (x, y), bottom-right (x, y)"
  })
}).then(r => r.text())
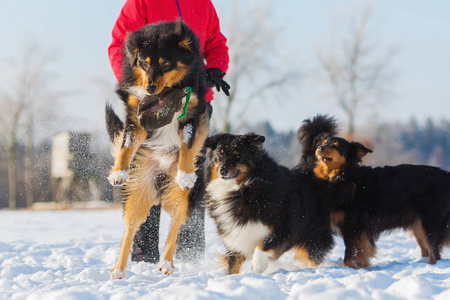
top-left (0, 209), bottom-right (450, 300)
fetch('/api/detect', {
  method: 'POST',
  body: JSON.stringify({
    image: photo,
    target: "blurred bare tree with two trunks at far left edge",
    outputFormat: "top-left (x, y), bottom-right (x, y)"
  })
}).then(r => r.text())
top-left (0, 45), bottom-right (57, 209)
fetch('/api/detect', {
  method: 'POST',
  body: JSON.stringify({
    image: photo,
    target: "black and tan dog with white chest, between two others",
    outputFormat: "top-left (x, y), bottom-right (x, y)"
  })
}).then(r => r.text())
top-left (204, 133), bottom-right (333, 274)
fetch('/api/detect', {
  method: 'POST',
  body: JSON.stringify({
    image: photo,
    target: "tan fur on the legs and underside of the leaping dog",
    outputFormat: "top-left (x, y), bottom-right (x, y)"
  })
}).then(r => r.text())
top-left (112, 101), bottom-right (209, 271)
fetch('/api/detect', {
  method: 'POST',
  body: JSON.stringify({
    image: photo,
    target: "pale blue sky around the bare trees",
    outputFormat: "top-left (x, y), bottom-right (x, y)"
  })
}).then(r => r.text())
top-left (0, 0), bottom-right (450, 134)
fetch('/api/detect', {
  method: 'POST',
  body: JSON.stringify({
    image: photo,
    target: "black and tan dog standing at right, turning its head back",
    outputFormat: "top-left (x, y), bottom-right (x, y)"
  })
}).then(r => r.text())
top-left (300, 116), bottom-right (450, 268)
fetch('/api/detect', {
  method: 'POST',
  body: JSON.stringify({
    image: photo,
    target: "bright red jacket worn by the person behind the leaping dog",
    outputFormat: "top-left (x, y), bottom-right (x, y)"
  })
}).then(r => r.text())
top-left (108, 0), bottom-right (229, 101)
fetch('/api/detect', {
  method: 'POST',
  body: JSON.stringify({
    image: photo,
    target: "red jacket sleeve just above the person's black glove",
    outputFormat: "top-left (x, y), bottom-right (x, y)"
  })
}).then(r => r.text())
top-left (204, 1), bottom-right (230, 73)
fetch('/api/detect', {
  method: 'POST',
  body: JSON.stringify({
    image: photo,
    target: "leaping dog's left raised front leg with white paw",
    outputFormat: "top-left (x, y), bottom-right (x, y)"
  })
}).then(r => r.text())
top-left (108, 122), bottom-right (147, 186)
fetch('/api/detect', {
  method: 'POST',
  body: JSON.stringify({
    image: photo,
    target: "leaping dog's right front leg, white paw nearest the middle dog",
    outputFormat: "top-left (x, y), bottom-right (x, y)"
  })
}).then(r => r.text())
top-left (175, 114), bottom-right (209, 190)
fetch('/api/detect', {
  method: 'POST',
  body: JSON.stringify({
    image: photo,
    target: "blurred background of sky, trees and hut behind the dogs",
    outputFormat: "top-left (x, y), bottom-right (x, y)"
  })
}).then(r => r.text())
top-left (0, 0), bottom-right (450, 209)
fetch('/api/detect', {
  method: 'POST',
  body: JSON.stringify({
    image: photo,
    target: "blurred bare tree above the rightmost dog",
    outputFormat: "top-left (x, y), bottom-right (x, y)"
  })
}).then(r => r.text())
top-left (317, 5), bottom-right (396, 138)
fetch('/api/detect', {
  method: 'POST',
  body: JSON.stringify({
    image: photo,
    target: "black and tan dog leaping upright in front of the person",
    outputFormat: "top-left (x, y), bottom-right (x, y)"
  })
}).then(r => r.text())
top-left (106, 21), bottom-right (209, 279)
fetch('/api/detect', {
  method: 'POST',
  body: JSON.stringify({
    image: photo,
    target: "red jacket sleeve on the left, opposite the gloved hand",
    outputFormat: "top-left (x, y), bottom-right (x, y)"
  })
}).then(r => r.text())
top-left (108, 0), bottom-right (147, 82)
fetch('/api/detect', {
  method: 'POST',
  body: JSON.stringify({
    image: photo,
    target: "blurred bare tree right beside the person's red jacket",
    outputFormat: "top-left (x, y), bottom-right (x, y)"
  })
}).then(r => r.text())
top-left (213, 0), bottom-right (299, 132)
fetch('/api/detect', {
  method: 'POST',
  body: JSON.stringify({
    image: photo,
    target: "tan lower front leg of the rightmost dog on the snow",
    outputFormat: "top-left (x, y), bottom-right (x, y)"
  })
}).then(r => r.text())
top-left (344, 233), bottom-right (377, 269)
